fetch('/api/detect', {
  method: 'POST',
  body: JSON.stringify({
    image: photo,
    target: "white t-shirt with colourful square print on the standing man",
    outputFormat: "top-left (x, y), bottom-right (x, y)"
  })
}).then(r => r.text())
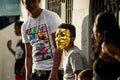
top-left (21, 9), bottom-right (62, 70)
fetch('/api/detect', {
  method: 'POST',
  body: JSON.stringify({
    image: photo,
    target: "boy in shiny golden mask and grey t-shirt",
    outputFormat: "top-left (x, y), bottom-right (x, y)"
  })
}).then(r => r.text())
top-left (55, 24), bottom-right (85, 80)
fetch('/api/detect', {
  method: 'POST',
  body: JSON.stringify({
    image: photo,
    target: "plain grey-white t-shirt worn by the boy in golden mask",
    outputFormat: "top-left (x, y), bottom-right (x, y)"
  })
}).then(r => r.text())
top-left (63, 46), bottom-right (86, 80)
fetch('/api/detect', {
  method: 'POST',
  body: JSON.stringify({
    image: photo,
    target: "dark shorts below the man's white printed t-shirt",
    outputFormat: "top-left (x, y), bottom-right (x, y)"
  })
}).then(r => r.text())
top-left (31, 70), bottom-right (63, 80)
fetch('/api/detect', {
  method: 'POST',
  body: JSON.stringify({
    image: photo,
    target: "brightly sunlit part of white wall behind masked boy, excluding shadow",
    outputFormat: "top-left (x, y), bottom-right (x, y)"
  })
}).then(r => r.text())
top-left (72, 0), bottom-right (89, 48)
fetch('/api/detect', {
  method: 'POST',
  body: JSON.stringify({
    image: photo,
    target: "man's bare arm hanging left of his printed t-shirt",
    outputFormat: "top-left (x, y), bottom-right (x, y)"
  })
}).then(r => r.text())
top-left (25, 43), bottom-right (32, 80)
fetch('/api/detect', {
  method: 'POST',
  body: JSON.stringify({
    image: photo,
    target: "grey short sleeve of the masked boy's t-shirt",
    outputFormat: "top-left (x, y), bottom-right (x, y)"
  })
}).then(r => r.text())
top-left (69, 53), bottom-right (84, 72)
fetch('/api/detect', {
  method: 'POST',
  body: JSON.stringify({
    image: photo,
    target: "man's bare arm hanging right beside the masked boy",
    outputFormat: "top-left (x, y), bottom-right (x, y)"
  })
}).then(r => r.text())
top-left (48, 33), bottom-right (62, 80)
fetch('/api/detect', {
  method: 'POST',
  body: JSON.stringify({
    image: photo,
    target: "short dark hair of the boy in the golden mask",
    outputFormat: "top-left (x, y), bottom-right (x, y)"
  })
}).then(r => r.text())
top-left (58, 23), bottom-right (76, 38)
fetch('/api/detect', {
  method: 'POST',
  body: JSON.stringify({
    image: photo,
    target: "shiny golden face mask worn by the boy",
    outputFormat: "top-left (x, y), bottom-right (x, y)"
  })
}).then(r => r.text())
top-left (55, 28), bottom-right (70, 49)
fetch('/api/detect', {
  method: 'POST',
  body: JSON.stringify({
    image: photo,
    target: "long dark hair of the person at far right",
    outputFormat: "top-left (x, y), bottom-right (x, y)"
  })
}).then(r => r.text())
top-left (92, 12), bottom-right (120, 59)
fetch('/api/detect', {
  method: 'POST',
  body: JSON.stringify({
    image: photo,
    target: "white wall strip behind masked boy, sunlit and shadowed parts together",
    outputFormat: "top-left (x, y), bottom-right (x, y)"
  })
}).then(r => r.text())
top-left (72, 0), bottom-right (91, 67)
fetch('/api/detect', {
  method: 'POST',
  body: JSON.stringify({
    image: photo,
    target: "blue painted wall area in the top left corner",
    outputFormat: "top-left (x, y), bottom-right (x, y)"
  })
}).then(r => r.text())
top-left (0, 0), bottom-right (21, 16)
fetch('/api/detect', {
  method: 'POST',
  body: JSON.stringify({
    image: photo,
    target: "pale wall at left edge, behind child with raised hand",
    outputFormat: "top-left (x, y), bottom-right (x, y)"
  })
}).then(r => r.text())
top-left (0, 24), bottom-right (18, 80)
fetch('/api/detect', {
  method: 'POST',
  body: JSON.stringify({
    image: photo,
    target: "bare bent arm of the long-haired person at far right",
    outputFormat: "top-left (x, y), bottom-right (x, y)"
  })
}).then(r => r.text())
top-left (102, 42), bottom-right (120, 62)
